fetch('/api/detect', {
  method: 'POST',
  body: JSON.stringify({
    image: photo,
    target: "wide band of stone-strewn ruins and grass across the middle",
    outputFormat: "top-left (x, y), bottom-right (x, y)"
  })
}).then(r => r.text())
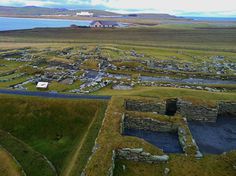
top-left (0, 45), bottom-right (236, 94)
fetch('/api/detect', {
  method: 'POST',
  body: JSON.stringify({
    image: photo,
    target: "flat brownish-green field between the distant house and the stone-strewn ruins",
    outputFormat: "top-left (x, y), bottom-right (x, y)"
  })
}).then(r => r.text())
top-left (0, 27), bottom-right (236, 52)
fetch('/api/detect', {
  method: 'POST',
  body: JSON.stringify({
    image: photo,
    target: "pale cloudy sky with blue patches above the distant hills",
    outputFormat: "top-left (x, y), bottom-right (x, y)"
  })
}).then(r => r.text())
top-left (0, 0), bottom-right (236, 17)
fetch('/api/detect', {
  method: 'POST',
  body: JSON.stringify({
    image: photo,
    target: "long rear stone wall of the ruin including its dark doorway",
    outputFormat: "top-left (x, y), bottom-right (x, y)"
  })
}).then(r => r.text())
top-left (125, 98), bottom-right (236, 122)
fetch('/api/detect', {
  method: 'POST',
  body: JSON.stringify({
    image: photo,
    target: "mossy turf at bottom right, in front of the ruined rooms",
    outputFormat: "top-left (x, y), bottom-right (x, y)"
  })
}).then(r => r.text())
top-left (114, 152), bottom-right (236, 176)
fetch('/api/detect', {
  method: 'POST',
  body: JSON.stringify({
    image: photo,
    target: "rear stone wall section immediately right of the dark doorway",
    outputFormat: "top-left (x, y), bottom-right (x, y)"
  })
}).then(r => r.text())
top-left (177, 100), bottom-right (218, 122)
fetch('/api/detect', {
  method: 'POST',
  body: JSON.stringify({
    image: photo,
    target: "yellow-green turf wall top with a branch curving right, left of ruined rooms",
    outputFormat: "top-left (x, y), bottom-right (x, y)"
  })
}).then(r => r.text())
top-left (85, 96), bottom-right (163, 176)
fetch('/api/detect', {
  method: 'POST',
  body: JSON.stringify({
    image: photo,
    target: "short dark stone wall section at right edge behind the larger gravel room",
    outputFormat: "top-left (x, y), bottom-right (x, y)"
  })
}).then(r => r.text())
top-left (218, 101), bottom-right (236, 117)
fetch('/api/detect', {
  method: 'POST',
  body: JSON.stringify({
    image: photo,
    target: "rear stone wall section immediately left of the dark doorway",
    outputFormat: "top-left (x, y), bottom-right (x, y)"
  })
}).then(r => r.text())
top-left (125, 100), bottom-right (166, 114)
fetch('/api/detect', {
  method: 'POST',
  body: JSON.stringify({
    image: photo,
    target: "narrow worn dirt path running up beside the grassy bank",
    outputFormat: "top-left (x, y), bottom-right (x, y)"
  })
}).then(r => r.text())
top-left (61, 110), bottom-right (99, 176)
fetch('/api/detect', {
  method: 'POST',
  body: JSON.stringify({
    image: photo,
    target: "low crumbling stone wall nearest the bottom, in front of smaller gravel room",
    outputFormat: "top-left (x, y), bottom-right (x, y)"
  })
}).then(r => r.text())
top-left (116, 148), bottom-right (169, 163)
